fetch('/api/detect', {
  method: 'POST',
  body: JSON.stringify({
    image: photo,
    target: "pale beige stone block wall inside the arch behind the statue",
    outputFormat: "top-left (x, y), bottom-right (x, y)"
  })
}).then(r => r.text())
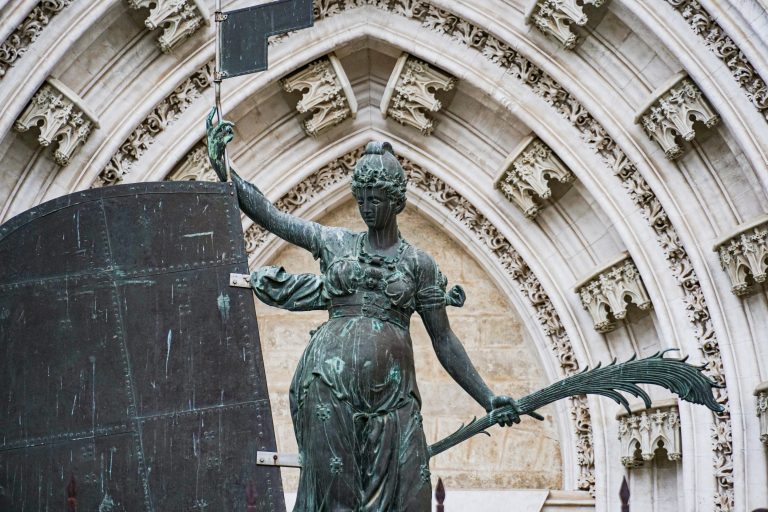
top-left (256, 198), bottom-right (562, 492)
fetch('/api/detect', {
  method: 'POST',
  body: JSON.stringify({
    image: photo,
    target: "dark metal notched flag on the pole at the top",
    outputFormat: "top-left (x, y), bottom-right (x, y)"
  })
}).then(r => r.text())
top-left (219, 0), bottom-right (314, 78)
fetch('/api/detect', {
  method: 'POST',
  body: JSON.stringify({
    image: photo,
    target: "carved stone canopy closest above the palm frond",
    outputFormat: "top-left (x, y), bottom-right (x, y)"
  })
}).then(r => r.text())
top-left (576, 254), bottom-right (652, 333)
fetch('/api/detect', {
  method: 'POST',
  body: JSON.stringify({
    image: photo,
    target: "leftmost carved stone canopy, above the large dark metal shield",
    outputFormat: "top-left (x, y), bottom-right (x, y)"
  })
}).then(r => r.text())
top-left (13, 77), bottom-right (99, 166)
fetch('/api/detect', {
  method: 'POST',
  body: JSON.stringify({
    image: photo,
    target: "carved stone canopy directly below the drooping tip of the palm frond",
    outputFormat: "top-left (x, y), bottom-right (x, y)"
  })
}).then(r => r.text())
top-left (616, 399), bottom-right (682, 468)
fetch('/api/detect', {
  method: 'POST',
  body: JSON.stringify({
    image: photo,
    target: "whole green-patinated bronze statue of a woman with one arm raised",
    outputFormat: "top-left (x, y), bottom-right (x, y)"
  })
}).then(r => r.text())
top-left (207, 110), bottom-right (519, 512)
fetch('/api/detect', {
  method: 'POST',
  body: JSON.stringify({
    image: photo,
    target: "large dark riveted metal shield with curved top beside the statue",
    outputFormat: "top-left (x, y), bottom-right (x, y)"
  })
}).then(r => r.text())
top-left (0, 182), bottom-right (285, 512)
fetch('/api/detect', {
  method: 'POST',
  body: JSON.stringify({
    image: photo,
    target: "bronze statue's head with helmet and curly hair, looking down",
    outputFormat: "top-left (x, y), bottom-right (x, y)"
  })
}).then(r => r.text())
top-left (352, 141), bottom-right (407, 226)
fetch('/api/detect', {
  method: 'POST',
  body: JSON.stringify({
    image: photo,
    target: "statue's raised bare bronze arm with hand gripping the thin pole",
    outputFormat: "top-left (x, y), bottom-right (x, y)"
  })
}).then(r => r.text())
top-left (206, 107), bottom-right (322, 255)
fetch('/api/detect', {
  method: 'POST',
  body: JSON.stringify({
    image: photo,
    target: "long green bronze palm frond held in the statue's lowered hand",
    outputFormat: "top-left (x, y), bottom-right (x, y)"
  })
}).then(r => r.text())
top-left (429, 350), bottom-right (723, 457)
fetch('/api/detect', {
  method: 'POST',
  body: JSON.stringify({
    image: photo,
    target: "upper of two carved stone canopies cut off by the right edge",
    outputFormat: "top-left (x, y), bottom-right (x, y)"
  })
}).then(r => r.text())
top-left (713, 215), bottom-right (768, 296)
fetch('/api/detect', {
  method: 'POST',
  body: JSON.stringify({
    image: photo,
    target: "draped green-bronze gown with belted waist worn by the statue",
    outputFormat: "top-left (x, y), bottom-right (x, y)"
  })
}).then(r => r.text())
top-left (251, 223), bottom-right (464, 512)
